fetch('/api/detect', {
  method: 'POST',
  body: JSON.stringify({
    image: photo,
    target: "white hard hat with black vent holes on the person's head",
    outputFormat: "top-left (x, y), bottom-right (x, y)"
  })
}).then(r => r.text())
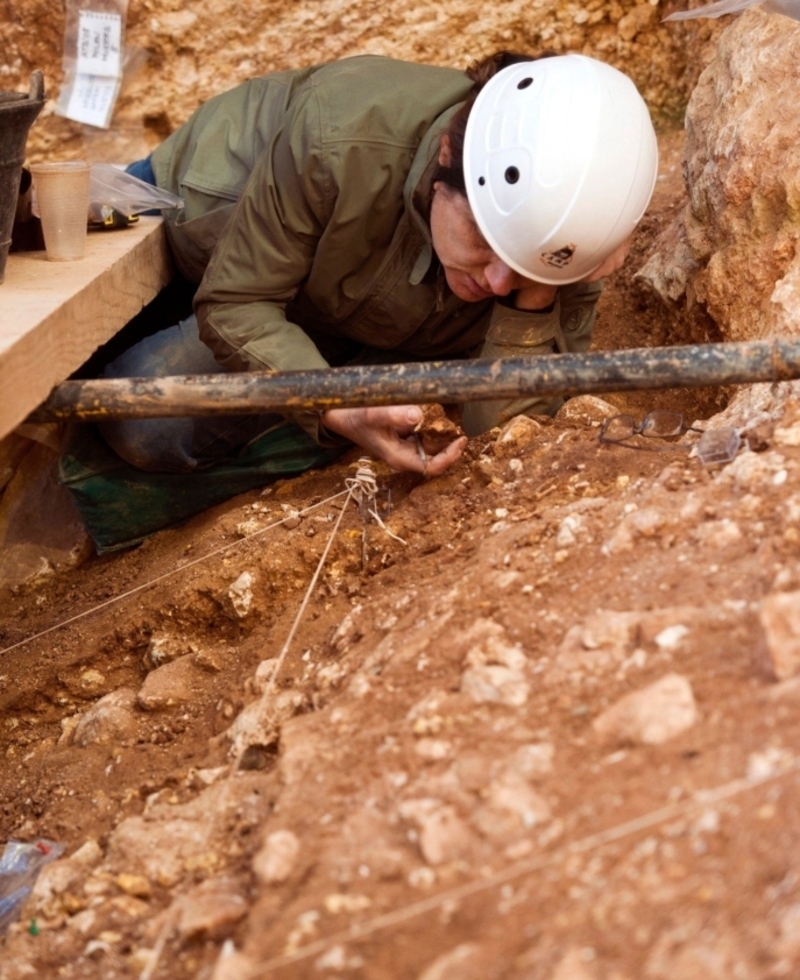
top-left (464, 54), bottom-right (658, 285)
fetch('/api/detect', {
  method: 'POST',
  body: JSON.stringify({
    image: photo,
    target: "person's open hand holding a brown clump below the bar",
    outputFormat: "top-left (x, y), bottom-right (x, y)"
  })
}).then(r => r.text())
top-left (322, 405), bottom-right (467, 476)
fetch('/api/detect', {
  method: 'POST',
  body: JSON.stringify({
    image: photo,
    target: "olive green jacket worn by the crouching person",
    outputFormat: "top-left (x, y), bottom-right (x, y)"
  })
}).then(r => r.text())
top-left (153, 56), bottom-right (600, 431)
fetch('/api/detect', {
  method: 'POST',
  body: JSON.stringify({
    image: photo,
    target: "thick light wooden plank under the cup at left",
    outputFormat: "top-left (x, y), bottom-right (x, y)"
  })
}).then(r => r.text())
top-left (0, 217), bottom-right (173, 439)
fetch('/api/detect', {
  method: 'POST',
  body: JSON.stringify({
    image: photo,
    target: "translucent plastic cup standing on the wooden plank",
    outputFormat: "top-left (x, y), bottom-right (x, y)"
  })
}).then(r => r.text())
top-left (30, 160), bottom-right (90, 262)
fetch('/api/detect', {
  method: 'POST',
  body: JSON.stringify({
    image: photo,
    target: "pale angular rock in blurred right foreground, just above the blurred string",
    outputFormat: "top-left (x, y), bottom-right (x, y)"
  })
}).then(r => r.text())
top-left (593, 674), bottom-right (697, 745)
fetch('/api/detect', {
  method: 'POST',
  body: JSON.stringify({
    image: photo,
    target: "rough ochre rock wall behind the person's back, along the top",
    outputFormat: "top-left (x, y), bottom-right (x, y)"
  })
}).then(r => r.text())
top-left (0, 0), bottom-right (720, 161)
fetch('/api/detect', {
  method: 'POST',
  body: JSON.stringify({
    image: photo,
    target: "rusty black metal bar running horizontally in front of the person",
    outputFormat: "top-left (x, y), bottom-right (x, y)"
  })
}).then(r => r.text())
top-left (29, 339), bottom-right (800, 422)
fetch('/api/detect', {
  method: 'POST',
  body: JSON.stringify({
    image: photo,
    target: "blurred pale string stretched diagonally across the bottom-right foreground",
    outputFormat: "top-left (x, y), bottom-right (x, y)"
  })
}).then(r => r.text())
top-left (241, 760), bottom-right (800, 980)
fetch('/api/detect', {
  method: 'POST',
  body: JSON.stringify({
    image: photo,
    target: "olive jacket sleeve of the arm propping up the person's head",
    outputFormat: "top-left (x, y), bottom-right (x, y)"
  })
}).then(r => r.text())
top-left (462, 281), bottom-right (603, 436)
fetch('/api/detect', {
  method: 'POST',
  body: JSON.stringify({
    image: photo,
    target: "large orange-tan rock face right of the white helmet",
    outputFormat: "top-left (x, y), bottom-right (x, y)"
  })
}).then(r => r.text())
top-left (639, 9), bottom-right (800, 340)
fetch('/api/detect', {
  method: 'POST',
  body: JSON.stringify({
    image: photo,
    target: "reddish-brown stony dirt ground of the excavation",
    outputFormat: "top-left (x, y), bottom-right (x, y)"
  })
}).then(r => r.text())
top-left (0, 133), bottom-right (800, 980)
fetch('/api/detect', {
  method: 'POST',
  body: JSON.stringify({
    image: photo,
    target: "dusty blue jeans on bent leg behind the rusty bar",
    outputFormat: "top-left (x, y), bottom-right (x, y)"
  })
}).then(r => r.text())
top-left (99, 316), bottom-right (283, 473)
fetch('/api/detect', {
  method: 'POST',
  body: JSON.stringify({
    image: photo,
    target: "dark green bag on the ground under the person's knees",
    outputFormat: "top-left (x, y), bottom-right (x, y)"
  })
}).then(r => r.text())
top-left (59, 422), bottom-right (349, 554)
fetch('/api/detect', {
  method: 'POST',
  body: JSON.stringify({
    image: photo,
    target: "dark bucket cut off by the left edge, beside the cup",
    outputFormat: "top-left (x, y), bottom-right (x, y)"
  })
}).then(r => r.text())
top-left (0, 71), bottom-right (46, 282)
